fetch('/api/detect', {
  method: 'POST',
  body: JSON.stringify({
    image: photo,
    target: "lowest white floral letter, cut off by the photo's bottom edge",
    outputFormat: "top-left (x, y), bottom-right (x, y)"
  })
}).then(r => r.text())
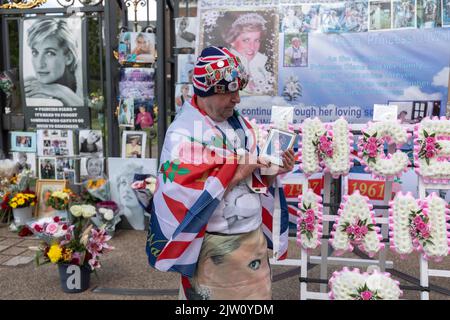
top-left (328, 267), bottom-right (403, 300)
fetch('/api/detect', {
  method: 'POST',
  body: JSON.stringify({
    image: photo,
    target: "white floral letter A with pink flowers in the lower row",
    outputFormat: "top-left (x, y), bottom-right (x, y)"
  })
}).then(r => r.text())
top-left (329, 190), bottom-right (384, 257)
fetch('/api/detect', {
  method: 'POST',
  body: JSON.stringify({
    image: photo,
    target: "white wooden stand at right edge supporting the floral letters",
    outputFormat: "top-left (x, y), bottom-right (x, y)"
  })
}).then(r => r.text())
top-left (419, 176), bottom-right (450, 300)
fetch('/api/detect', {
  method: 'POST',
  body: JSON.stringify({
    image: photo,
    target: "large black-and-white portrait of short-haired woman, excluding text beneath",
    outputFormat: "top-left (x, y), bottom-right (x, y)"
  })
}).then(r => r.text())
top-left (21, 17), bottom-right (85, 107)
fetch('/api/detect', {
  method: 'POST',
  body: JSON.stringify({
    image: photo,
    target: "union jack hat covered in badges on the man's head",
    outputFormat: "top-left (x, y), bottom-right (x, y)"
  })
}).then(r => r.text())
top-left (192, 46), bottom-right (248, 97)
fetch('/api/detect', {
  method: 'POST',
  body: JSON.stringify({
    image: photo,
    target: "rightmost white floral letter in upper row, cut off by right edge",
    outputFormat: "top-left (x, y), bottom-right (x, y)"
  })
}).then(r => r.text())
top-left (414, 117), bottom-right (450, 184)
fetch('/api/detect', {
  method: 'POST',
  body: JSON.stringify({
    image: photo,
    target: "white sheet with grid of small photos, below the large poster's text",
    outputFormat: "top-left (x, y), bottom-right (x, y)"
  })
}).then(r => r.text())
top-left (37, 129), bottom-right (74, 157)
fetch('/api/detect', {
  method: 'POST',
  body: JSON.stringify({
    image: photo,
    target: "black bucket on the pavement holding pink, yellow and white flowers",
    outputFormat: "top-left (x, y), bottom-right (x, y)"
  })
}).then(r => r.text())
top-left (58, 264), bottom-right (91, 293)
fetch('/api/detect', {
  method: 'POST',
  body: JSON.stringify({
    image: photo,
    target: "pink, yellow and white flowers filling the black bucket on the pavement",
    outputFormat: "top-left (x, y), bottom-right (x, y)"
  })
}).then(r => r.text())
top-left (31, 205), bottom-right (114, 270)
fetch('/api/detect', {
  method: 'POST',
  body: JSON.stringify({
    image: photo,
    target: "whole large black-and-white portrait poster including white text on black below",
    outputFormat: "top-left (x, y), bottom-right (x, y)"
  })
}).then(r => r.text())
top-left (20, 17), bottom-right (90, 129)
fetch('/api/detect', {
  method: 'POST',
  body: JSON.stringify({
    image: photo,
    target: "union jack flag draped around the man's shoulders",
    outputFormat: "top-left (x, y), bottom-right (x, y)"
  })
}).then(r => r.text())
top-left (146, 96), bottom-right (289, 277)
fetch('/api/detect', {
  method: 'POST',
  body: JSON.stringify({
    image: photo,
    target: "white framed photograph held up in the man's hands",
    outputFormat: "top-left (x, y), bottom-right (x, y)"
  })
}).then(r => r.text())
top-left (261, 129), bottom-right (297, 167)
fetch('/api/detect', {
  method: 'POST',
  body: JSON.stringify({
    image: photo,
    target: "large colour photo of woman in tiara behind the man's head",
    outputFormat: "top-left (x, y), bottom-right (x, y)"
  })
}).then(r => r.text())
top-left (199, 9), bottom-right (279, 95)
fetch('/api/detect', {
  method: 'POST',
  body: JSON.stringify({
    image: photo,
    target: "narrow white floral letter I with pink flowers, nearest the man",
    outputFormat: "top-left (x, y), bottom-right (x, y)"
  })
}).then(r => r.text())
top-left (297, 189), bottom-right (323, 250)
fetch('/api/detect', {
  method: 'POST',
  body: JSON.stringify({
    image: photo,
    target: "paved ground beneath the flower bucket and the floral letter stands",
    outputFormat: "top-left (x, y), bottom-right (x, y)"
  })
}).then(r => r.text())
top-left (0, 227), bottom-right (450, 300)
